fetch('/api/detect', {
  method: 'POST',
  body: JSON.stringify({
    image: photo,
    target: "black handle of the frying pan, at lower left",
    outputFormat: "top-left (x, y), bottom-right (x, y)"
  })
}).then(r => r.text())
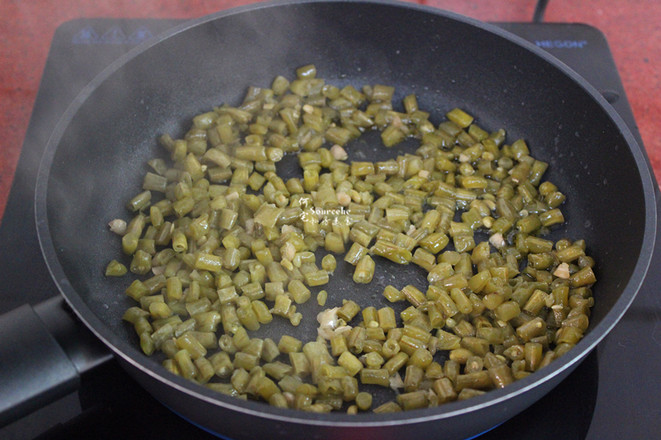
top-left (0, 296), bottom-right (112, 427)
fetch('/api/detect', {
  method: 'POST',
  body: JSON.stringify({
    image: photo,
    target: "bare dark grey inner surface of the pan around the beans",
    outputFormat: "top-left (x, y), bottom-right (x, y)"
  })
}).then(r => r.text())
top-left (37, 2), bottom-right (650, 434)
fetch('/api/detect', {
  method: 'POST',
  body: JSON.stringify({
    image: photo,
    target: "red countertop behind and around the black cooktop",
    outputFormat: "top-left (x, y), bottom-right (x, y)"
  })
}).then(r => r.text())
top-left (0, 0), bottom-right (661, 219)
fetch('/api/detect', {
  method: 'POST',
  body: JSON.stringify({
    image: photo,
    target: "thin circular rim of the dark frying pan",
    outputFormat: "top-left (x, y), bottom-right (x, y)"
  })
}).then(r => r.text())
top-left (34, 0), bottom-right (658, 427)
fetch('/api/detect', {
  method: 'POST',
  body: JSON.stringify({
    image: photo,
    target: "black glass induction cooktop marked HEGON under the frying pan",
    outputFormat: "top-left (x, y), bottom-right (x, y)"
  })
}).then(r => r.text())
top-left (0, 19), bottom-right (661, 440)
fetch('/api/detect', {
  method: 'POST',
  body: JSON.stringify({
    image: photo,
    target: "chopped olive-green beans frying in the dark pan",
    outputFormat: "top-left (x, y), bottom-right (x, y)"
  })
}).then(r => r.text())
top-left (105, 65), bottom-right (598, 414)
